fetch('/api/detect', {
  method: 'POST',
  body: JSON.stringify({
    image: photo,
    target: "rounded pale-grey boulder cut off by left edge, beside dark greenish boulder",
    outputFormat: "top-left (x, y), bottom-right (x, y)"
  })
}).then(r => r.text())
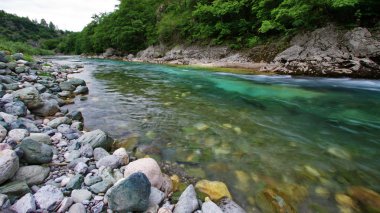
top-left (0, 149), bottom-right (19, 184)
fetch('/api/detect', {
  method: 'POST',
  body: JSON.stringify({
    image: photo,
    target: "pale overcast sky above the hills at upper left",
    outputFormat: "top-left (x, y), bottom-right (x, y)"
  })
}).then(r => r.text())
top-left (0, 0), bottom-right (119, 32)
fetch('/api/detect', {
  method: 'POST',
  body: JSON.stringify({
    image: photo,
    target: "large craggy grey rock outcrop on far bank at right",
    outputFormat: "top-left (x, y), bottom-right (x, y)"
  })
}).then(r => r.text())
top-left (264, 25), bottom-right (380, 78)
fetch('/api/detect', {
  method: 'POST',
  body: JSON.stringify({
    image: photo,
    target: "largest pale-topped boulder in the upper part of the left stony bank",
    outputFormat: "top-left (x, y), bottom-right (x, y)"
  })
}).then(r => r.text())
top-left (14, 87), bottom-right (44, 110)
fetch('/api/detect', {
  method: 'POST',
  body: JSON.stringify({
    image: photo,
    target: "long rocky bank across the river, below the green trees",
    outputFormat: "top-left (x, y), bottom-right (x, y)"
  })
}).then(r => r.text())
top-left (86, 25), bottom-right (380, 79)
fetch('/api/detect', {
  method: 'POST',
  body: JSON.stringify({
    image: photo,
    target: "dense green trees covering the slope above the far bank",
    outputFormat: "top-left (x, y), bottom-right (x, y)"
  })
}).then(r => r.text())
top-left (58, 0), bottom-right (380, 53)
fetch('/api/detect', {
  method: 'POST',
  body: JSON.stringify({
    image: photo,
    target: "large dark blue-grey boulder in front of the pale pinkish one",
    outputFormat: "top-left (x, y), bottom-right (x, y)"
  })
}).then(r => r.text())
top-left (107, 172), bottom-right (151, 212)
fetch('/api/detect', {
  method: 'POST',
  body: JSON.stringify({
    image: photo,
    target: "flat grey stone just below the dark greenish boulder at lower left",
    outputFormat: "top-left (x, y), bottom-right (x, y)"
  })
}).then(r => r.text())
top-left (12, 166), bottom-right (50, 186)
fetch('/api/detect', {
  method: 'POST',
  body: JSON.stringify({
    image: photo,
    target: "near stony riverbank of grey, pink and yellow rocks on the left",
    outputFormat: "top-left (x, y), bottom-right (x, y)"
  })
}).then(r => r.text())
top-left (0, 51), bottom-right (245, 213)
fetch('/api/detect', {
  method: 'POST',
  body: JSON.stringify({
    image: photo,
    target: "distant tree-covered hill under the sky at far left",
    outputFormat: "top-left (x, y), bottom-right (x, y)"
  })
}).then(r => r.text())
top-left (0, 10), bottom-right (65, 46)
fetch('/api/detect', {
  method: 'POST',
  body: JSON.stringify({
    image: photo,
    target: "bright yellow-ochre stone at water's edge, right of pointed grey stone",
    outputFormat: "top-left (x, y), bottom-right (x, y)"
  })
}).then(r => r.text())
top-left (195, 180), bottom-right (232, 202)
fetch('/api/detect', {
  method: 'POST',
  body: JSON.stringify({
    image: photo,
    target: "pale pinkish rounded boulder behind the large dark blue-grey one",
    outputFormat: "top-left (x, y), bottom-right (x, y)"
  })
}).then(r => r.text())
top-left (124, 158), bottom-right (164, 189)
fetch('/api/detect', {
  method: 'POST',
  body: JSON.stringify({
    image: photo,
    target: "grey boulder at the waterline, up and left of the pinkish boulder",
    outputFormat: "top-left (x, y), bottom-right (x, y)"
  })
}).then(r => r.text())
top-left (77, 129), bottom-right (113, 150)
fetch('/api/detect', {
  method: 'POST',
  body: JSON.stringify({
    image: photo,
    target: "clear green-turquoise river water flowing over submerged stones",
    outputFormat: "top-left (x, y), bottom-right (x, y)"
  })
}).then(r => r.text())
top-left (55, 57), bottom-right (380, 212)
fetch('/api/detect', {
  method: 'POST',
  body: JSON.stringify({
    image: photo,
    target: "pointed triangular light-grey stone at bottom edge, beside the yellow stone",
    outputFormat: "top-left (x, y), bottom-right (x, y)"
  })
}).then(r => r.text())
top-left (173, 184), bottom-right (199, 213)
